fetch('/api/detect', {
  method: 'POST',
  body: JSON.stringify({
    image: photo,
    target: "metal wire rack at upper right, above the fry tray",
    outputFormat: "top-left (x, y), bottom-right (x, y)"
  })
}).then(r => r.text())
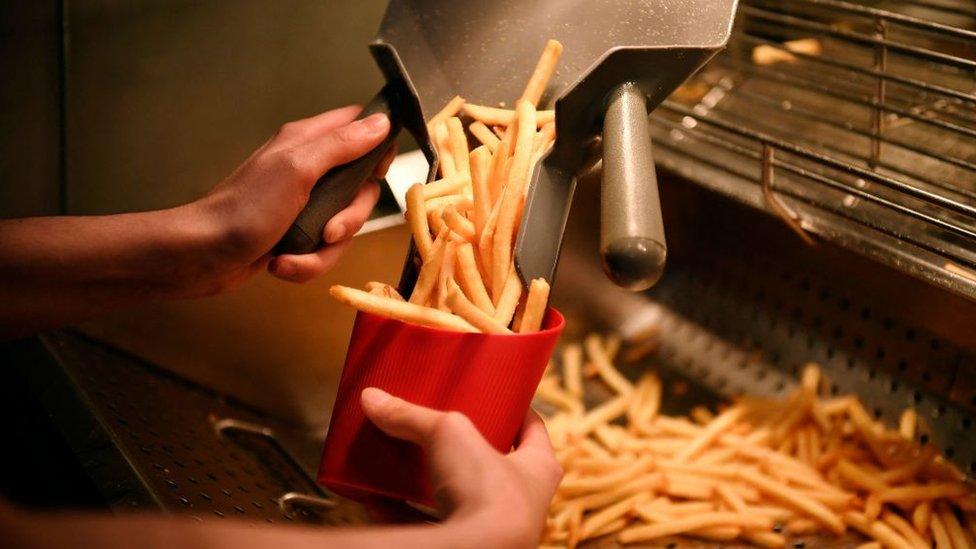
top-left (652, 0), bottom-right (976, 299)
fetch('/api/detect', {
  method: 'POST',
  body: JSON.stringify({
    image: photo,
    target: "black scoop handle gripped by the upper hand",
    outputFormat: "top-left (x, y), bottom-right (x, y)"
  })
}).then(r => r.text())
top-left (271, 84), bottom-right (401, 255)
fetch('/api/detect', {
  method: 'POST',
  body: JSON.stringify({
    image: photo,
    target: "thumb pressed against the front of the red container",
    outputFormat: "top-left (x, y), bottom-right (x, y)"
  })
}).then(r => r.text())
top-left (361, 387), bottom-right (444, 446)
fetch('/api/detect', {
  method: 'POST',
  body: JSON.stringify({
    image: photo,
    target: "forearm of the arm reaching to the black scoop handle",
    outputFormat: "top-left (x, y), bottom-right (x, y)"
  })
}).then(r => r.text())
top-left (0, 204), bottom-right (214, 340)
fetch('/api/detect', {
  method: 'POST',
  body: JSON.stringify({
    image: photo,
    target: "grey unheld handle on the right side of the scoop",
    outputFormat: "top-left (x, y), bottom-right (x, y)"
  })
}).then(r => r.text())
top-left (600, 83), bottom-right (667, 291)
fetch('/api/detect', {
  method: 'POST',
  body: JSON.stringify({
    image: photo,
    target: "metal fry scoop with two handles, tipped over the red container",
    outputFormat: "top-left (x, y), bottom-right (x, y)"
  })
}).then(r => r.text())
top-left (270, 0), bottom-right (736, 290)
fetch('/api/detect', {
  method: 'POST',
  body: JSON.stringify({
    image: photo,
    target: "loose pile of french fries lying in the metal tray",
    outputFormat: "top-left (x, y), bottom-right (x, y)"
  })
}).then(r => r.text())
top-left (536, 335), bottom-right (976, 549)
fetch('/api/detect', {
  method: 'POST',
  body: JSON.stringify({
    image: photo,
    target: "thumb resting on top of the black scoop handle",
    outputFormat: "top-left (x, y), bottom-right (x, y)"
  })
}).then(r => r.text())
top-left (299, 113), bottom-right (390, 174)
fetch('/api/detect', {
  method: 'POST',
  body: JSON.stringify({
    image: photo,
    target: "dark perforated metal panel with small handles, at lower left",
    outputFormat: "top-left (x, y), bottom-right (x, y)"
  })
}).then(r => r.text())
top-left (30, 333), bottom-right (362, 524)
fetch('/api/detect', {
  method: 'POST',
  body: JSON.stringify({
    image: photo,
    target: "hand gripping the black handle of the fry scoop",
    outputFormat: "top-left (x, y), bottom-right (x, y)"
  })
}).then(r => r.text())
top-left (184, 106), bottom-right (394, 295)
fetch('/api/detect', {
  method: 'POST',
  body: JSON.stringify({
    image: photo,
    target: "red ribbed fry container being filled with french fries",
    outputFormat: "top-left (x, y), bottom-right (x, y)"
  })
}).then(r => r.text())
top-left (318, 309), bottom-right (565, 506)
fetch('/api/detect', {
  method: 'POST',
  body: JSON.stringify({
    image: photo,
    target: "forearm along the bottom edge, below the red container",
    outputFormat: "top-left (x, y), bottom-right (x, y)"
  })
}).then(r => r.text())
top-left (0, 506), bottom-right (518, 549)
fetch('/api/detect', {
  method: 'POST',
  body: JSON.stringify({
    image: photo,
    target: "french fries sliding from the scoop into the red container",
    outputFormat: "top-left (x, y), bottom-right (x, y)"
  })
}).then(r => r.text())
top-left (330, 40), bottom-right (562, 334)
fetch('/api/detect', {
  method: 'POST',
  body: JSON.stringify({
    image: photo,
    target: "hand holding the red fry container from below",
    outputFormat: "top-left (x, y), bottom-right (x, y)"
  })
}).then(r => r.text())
top-left (362, 388), bottom-right (562, 547)
